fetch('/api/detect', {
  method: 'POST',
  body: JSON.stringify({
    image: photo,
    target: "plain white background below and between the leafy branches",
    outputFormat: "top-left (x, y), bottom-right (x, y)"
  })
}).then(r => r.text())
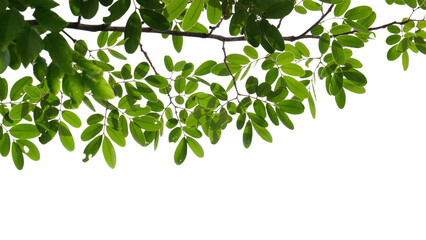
top-left (0, 1), bottom-right (426, 240)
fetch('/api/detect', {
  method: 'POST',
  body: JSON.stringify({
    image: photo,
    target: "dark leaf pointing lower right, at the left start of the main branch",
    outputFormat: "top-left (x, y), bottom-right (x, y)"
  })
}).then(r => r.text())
top-left (33, 7), bottom-right (68, 33)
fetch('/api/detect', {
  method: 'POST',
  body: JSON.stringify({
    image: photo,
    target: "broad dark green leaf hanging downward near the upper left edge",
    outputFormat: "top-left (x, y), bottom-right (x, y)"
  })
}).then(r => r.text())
top-left (16, 27), bottom-right (44, 67)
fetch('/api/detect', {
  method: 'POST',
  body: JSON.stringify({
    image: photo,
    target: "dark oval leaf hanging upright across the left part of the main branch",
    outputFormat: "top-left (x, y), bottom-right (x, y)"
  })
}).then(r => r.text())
top-left (124, 12), bottom-right (142, 53)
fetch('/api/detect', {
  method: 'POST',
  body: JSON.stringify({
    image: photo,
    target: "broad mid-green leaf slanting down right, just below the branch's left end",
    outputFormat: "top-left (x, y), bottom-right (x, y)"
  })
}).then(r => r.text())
top-left (43, 33), bottom-right (74, 75)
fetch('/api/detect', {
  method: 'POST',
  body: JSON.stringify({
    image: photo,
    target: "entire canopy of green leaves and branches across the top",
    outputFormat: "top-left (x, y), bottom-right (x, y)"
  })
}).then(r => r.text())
top-left (0, 0), bottom-right (426, 169)
